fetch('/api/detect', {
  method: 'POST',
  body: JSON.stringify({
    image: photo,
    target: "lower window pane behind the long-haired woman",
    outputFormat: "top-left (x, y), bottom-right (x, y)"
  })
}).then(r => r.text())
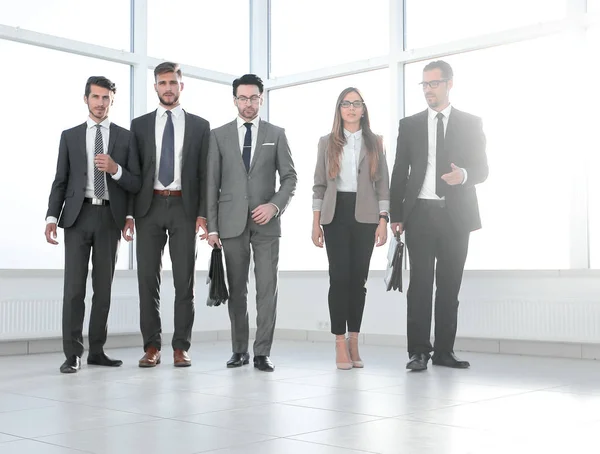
top-left (270, 70), bottom-right (393, 270)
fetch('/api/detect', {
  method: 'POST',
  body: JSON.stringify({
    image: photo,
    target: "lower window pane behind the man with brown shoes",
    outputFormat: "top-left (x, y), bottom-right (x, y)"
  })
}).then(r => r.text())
top-left (148, 72), bottom-right (237, 270)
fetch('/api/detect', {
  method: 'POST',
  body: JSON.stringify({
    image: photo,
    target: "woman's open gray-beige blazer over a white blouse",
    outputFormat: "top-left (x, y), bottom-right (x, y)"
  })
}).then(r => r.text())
top-left (313, 134), bottom-right (390, 225)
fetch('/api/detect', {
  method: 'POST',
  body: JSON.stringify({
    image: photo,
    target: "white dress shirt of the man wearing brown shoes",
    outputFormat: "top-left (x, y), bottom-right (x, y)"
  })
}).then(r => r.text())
top-left (154, 105), bottom-right (185, 191)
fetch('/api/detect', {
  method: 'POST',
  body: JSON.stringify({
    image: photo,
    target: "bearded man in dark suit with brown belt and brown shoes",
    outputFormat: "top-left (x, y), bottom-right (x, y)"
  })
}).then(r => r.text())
top-left (127, 62), bottom-right (210, 367)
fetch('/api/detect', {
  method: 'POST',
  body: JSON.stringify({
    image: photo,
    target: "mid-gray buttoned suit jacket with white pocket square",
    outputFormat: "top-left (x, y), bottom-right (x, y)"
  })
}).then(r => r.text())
top-left (206, 120), bottom-right (297, 238)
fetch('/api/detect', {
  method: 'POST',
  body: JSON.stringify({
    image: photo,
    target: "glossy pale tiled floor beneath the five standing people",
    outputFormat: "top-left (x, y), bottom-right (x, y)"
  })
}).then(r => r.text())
top-left (0, 341), bottom-right (600, 454)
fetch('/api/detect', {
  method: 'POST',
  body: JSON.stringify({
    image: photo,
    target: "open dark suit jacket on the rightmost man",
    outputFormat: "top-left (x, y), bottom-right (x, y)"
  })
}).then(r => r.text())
top-left (390, 107), bottom-right (489, 232)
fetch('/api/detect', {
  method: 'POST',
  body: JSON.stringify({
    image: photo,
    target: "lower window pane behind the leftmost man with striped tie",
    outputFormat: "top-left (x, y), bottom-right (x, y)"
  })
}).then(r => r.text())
top-left (0, 40), bottom-right (130, 268)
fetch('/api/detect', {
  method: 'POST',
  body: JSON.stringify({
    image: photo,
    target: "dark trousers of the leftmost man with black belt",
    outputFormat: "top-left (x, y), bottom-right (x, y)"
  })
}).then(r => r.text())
top-left (62, 203), bottom-right (121, 358)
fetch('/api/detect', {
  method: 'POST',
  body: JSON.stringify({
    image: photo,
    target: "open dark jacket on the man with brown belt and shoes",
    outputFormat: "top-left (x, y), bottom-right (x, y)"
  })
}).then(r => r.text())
top-left (129, 110), bottom-right (210, 220)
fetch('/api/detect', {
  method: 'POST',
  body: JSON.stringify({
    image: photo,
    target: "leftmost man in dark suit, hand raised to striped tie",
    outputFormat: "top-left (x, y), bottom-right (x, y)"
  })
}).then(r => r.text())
top-left (46, 77), bottom-right (141, 373)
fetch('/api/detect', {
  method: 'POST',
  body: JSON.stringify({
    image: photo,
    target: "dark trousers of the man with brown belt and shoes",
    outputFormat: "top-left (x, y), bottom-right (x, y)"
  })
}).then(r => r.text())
top-left (136, 195), bottom-right (196, 351)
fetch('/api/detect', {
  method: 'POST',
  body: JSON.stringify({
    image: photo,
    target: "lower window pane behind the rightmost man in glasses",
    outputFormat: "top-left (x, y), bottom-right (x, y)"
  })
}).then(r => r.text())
top-left (405, 36), bottom-right (583, 269)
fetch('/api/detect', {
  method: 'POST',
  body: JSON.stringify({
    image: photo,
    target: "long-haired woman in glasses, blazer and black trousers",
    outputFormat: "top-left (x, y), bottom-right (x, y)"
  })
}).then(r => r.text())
top-left (312, 87), bottom-right (390, 370)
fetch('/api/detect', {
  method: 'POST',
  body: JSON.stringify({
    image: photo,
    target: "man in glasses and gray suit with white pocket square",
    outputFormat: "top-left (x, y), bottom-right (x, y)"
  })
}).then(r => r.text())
top-left (207, 74), bottom-right (297, 372)
